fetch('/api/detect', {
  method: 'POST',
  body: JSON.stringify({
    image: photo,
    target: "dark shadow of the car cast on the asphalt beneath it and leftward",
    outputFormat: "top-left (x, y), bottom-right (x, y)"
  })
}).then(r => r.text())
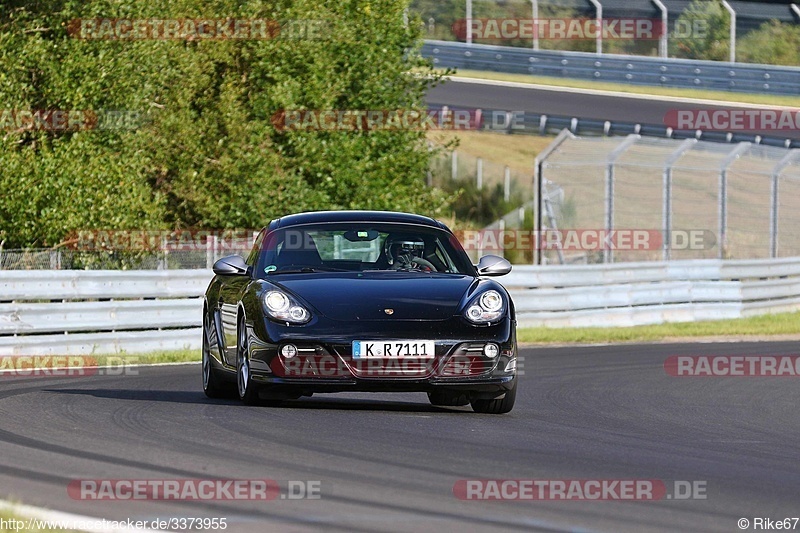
top-left (43, 389), bottom-right (472, 413)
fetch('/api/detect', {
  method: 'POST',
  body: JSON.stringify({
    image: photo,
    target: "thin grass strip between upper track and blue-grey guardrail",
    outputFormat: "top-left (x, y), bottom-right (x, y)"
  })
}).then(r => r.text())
top-left (452, 69), bottom-right (800, 107)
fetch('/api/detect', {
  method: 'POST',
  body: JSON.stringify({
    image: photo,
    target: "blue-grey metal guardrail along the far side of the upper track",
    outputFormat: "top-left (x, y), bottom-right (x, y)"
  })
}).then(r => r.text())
top-left (422, 41), bottom-right (800, 96)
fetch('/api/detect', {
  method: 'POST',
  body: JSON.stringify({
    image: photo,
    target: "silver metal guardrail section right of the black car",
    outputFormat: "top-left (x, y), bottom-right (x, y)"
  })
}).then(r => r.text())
top-left (501, 258), bottom-right (800, 327)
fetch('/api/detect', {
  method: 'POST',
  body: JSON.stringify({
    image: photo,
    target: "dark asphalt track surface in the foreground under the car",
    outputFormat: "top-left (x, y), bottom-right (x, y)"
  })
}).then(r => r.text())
top-left (0, 342), bottom-right (800, 532)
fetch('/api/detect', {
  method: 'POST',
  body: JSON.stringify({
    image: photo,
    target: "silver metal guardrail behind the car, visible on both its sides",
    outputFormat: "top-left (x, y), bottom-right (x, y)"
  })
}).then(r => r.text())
top-left (0, 258), bottom-right (800, 356)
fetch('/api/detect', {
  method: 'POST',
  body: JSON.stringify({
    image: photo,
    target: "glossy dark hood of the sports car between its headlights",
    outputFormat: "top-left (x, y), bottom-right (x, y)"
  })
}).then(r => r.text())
top-left (270, 271), bottom-right (477, 321)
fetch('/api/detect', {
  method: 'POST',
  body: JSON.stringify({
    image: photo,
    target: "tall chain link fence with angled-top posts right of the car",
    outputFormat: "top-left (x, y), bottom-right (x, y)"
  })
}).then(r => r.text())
top-left (537, 131), bottom-right (800, 263)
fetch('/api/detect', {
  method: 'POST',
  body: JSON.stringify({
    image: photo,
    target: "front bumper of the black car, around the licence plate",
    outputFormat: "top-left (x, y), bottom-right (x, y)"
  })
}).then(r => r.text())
top-left (248, 317), bottom-right (517, 398)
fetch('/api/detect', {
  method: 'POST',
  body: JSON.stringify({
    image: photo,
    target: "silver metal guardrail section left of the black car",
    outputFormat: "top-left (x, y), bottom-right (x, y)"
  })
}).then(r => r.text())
top-left (0, 269), bottom-right (213, 355)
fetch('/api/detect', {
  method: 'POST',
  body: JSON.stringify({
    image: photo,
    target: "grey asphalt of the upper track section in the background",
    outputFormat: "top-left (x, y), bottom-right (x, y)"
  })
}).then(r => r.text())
top-left (427, 81), bottom-right (800, 139)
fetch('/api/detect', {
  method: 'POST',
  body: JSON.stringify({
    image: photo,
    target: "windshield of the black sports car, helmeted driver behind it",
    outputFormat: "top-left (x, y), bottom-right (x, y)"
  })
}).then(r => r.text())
top-left (256, 223), bottom-right (475, 275)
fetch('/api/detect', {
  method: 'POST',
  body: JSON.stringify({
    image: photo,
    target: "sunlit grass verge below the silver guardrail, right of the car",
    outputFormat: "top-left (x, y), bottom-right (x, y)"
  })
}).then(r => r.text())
top-left (517, 312), bottom-right (800, 344)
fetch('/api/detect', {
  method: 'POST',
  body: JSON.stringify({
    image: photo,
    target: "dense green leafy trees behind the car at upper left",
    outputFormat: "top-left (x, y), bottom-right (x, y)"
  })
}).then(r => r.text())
top-left (0, 0), bottom-right (450, 247)
